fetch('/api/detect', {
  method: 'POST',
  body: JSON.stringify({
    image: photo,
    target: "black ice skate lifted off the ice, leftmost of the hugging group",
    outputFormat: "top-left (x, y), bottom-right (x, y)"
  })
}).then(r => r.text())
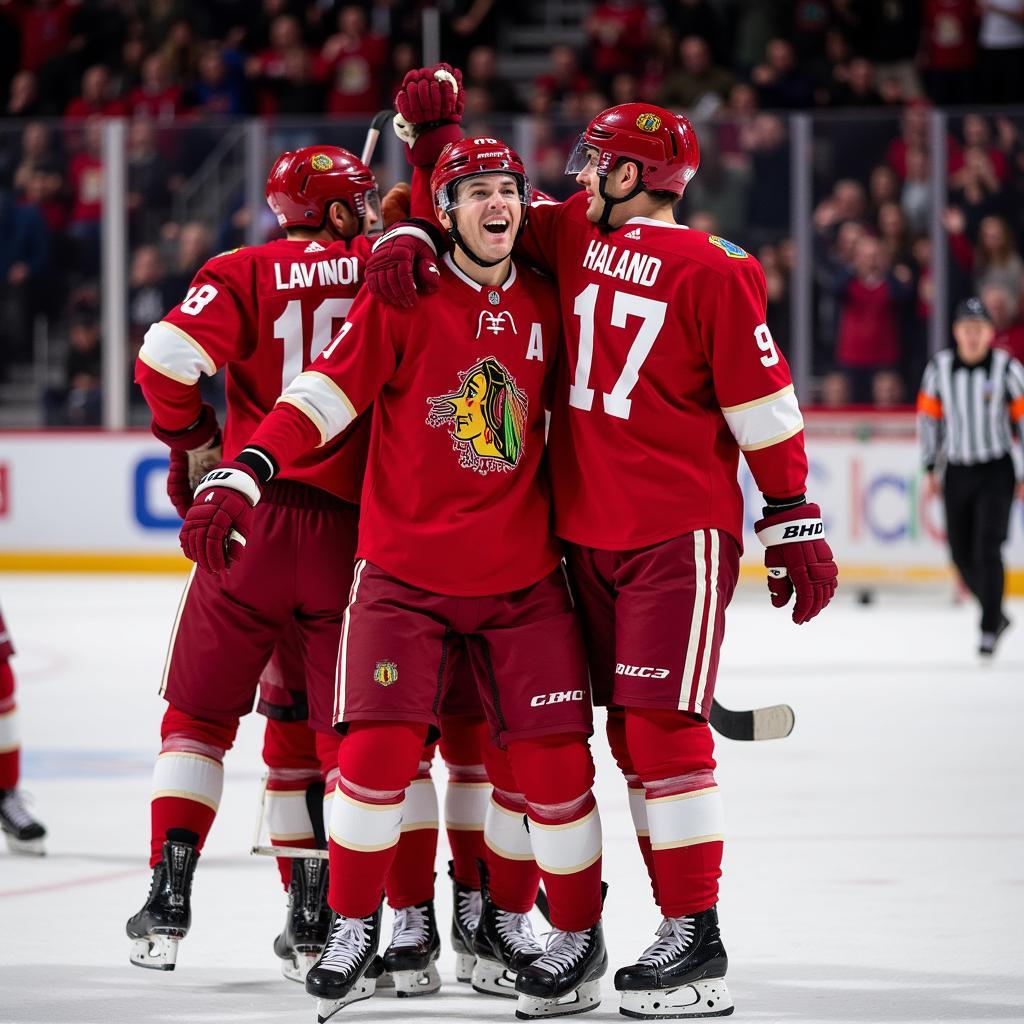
top-left (125, 828), bottom-right (199, 971)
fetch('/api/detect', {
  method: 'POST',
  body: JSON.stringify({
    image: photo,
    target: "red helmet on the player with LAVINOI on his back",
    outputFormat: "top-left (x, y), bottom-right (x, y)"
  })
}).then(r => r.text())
top-left (266, 145), bottom-right (380, 227)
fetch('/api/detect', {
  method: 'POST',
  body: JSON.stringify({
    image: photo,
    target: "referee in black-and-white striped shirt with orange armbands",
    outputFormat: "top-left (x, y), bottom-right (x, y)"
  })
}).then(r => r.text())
top-left (918, 298), bottom-right (1024, 657)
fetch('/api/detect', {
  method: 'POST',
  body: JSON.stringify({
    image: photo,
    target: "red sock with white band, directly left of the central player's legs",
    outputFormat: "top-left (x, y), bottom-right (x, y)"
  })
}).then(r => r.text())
top-left (263, 718), bottom-right (322, 892)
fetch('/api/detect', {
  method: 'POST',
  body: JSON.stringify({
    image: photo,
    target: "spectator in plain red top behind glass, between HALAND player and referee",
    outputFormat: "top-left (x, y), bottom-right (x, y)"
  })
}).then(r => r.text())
top-left (835, 234), bottom-right (912, 404)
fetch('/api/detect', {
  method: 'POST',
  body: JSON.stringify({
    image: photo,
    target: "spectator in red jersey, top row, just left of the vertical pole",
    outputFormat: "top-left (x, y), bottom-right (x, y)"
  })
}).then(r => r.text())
top-left (321, 5), bottom-right (388, 114)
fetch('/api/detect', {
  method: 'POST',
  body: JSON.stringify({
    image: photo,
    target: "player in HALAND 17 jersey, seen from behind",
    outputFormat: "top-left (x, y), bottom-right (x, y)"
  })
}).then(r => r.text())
top-left (368, 72), bottom-right (837, 1018)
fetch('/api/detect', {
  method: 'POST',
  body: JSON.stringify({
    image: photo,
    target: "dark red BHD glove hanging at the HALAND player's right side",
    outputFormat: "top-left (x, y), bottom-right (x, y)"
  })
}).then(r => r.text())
top-left (754, 504), bottom-right (839, 626)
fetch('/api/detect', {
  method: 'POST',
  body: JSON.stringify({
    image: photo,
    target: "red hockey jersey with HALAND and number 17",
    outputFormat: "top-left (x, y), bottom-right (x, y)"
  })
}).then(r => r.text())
top-left (521, 193), bottom-right (807, 550)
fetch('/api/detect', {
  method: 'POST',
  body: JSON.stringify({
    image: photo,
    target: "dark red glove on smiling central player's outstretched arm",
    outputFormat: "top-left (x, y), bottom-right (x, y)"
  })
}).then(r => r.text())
top-left (179, 462), bottom-right (261, 572)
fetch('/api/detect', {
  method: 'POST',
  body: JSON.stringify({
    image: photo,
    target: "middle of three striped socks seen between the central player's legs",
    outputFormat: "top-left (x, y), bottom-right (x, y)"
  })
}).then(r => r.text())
top-left (440, 715), bottom-right (490, 889)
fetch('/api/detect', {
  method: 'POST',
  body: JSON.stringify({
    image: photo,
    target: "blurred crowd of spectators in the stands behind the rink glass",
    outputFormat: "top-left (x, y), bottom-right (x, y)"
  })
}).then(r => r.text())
top-left (0, 0), bottom-right (1024, 426)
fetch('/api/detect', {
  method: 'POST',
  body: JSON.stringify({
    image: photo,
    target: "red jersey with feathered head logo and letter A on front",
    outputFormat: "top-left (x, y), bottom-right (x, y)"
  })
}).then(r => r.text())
top-left (250, 250), bottom-right (560, 596)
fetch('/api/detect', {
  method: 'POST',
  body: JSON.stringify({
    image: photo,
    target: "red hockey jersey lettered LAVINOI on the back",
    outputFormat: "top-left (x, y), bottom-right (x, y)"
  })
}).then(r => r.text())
top-left (135, 237), bottom-right (370, 502)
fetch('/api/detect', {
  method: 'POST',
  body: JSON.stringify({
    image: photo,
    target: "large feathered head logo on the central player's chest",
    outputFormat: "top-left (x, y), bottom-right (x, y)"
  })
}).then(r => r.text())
top-left (427, 355), bottom-right (528, 475)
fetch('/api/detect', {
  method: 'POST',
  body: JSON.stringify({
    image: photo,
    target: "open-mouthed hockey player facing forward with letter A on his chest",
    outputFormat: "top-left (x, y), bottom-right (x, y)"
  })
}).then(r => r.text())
top-left (181, 139), bottom-right (606, 1020)
